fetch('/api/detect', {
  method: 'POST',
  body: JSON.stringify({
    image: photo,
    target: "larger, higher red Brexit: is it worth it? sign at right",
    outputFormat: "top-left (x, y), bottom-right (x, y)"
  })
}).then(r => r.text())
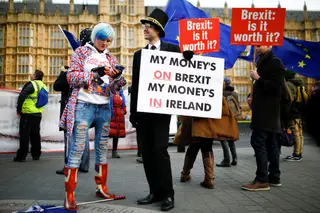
top-left (230, 8), bottom-right (286, 46)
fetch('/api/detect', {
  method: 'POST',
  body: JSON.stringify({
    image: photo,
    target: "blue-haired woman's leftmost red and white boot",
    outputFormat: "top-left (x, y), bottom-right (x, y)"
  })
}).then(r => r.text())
top-left (64, 167), bottom-right (78, 210)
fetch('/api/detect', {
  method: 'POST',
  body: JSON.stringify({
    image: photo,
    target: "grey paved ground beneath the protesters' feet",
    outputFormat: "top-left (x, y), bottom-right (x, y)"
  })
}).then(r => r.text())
top-left (0, 137), bottom-right (320, 213)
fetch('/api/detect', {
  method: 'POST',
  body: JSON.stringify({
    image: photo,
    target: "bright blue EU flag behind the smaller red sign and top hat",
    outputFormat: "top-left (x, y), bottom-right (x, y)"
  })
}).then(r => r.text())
top-left (163, 0), bottom-right (245, 69)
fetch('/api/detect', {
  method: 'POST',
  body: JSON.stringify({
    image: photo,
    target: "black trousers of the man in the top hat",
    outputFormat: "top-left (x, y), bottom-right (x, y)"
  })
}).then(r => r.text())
top-left (138, 113), bottom-right (174, 197)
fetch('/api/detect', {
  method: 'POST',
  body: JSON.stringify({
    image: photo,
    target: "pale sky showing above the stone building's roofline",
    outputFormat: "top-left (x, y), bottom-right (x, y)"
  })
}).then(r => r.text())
top-left (8, 0), bottom-right (320, 12)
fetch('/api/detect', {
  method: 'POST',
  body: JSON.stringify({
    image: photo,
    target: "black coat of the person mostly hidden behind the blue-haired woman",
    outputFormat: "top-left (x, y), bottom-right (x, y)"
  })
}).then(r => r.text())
top-left (53, 71), bottom-right (70, 131)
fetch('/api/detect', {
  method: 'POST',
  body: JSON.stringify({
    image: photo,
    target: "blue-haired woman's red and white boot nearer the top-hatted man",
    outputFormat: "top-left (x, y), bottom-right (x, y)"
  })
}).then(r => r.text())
top-left (94, 164), bottom-right (116, 199)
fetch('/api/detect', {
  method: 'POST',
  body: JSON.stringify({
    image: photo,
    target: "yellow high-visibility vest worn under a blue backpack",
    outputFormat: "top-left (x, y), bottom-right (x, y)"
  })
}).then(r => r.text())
top-left (22, 80), bottom-right (48, 114)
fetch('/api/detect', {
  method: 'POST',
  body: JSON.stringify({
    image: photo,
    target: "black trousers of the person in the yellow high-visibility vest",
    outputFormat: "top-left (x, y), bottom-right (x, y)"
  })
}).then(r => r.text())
top-left (17, 114), bottom-right (41, 159)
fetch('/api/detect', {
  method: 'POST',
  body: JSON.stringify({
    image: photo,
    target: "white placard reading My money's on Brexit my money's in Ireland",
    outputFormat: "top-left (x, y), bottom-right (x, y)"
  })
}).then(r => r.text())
top-left (137, 49), bottom-right (224, 119)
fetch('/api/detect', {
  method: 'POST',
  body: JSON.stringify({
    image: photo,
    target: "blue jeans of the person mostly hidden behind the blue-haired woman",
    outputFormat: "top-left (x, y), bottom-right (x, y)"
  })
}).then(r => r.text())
top-left (64, 131), bottom-right (90, 171)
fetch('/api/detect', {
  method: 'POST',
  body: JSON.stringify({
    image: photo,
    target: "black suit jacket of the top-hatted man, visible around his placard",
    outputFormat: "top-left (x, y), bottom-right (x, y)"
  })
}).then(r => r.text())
top-left (130, 41), bottom-right (180, 117)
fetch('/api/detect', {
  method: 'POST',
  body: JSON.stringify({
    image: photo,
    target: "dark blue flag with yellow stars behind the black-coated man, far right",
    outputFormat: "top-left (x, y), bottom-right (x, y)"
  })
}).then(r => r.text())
top-left (239, 37), bottom-right (320, 80)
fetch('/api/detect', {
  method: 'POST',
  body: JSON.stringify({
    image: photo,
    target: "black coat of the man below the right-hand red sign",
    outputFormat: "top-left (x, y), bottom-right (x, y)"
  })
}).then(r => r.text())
top-left (251, 51), bottom-right (284, 133)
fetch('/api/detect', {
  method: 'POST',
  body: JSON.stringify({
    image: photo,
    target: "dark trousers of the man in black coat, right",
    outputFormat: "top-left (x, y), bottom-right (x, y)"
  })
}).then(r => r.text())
top-left (251, 130), bottom-right (280, 183)
